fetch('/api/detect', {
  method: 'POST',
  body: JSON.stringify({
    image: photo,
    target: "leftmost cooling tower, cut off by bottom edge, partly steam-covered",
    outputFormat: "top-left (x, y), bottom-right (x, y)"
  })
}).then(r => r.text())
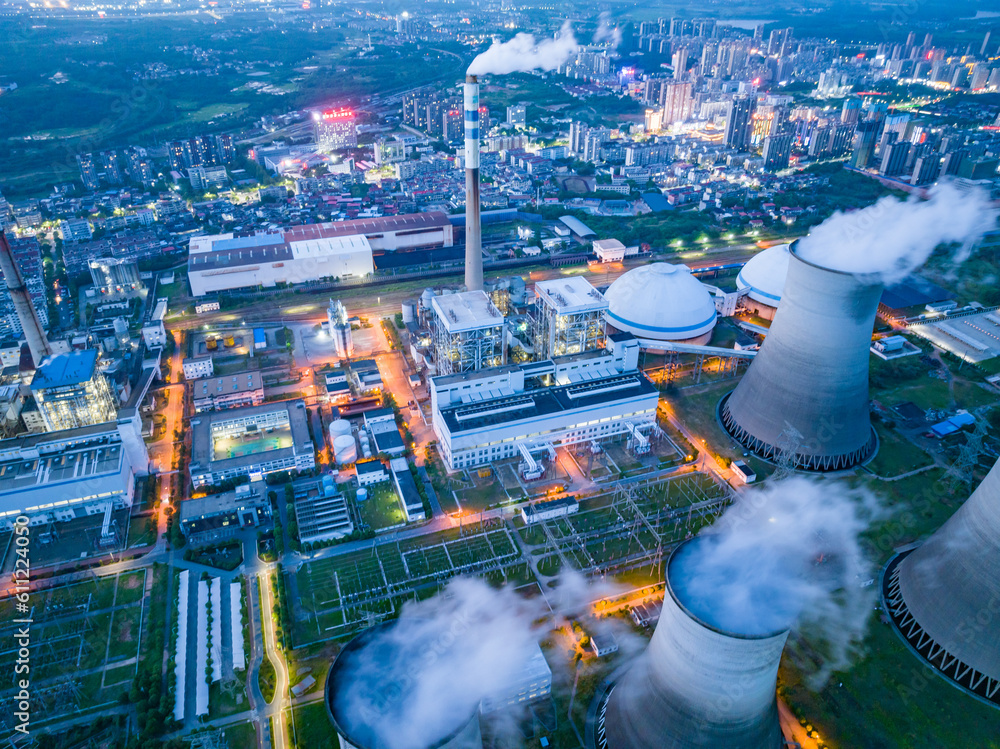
top-left (326, 619), bottom-right (483, 749)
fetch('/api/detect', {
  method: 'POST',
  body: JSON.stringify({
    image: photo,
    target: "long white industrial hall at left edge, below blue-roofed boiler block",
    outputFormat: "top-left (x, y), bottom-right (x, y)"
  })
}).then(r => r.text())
top-left (0, 421), bottom-right (149, 529)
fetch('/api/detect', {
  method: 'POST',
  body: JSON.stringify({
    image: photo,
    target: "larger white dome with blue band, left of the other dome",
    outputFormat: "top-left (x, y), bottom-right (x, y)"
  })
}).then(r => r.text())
top-left (604, 263), bottom-right (717, 351)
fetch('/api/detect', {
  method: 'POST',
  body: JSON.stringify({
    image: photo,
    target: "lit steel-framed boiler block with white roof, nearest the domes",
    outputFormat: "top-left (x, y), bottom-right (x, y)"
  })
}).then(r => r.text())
top-left (531, 276), bottom-right (608, 359)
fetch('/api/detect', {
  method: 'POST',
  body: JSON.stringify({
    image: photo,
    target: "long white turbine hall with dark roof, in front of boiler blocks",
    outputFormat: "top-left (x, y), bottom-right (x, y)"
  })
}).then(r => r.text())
top-left (430, 337), bottom-right (659, 470)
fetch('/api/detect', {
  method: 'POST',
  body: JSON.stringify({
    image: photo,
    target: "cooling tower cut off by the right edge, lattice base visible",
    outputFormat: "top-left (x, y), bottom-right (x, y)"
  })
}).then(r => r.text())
top-left (882, 461), bottom-right (1000, 707)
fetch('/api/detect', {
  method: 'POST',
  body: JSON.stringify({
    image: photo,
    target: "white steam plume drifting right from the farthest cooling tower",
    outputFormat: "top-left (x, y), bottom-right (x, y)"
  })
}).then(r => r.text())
top-left (797, 183), bottom-right (997, 284)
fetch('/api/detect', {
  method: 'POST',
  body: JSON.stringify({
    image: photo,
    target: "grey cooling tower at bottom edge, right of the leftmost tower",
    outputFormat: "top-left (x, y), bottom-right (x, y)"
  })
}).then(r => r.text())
top-left (594, 542), bottom-right (788, 749)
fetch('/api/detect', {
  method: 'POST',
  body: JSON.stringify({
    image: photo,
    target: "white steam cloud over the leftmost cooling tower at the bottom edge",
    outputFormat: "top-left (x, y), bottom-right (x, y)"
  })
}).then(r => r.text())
top-left (336, 573), bottom-right (616, 749)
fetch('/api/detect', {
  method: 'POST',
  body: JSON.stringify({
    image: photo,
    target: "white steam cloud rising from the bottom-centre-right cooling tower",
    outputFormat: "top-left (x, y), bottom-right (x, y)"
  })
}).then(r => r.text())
top-left (670, 477), bottom-right (881, 683)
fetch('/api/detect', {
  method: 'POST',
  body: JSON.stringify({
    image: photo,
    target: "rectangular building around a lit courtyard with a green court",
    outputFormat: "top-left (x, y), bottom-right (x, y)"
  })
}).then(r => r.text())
top-left (190, 400), bottom-right (316, 488)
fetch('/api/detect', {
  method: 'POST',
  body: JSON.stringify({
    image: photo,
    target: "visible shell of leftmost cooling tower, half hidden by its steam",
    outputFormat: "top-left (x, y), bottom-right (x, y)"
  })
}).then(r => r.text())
top-left (325, 622), bottom-right (483, 749)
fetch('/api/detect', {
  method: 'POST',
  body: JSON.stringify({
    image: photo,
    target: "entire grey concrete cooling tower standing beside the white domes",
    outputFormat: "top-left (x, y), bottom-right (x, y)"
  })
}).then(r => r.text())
top-left (720, 243), bottom-right (882, 471)
